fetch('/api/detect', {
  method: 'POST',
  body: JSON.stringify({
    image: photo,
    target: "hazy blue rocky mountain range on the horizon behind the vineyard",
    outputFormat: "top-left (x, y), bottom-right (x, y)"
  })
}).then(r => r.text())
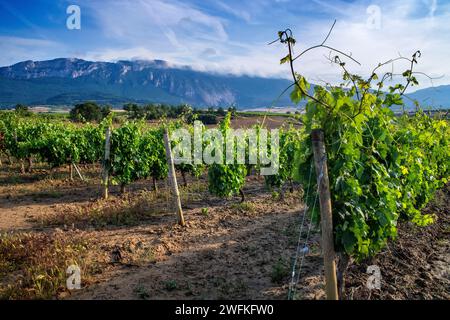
top-left (0, 58), bottom-right (450, 109)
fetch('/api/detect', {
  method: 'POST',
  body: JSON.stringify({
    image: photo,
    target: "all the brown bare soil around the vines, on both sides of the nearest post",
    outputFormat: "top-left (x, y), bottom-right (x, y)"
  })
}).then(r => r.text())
top-left (0, 165), bottom-right (450, 299)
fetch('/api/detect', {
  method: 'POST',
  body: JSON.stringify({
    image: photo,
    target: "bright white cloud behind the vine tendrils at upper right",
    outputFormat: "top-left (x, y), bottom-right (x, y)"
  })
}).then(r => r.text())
top-left (274, 0), bottom-right (450, 89)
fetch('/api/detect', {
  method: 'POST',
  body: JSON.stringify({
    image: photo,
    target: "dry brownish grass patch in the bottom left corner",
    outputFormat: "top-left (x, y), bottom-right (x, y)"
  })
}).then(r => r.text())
top-left (0, 232), bottom-right (93, 299)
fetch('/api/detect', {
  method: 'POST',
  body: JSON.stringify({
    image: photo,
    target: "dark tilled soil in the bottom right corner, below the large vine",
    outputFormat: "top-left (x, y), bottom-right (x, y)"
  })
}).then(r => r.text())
top-left (346, 185), bottom-right (450, 300)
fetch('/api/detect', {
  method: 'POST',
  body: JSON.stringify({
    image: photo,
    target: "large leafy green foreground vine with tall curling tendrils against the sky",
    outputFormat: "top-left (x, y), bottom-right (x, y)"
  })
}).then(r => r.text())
top-left (272, 21), bottom-right (450, 292)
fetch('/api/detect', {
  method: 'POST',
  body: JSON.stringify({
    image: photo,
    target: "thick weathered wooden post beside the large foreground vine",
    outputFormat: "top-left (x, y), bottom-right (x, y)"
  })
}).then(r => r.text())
top-left (311, 129), bottom-right (338, 300)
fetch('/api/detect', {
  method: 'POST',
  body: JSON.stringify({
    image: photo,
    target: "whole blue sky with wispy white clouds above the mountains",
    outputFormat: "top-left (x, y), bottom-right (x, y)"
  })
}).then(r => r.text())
top-left (0, 0), bottom-right (450, 87)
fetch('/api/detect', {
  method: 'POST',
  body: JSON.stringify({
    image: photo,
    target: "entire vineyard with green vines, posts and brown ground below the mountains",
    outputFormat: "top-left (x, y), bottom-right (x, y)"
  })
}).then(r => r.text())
top-left (0, 30), bottom-right (450, 299)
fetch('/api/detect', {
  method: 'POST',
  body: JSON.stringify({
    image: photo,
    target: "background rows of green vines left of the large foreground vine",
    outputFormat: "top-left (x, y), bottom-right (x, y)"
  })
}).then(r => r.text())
top-left (0, 113), bottom-right (302, 201)
